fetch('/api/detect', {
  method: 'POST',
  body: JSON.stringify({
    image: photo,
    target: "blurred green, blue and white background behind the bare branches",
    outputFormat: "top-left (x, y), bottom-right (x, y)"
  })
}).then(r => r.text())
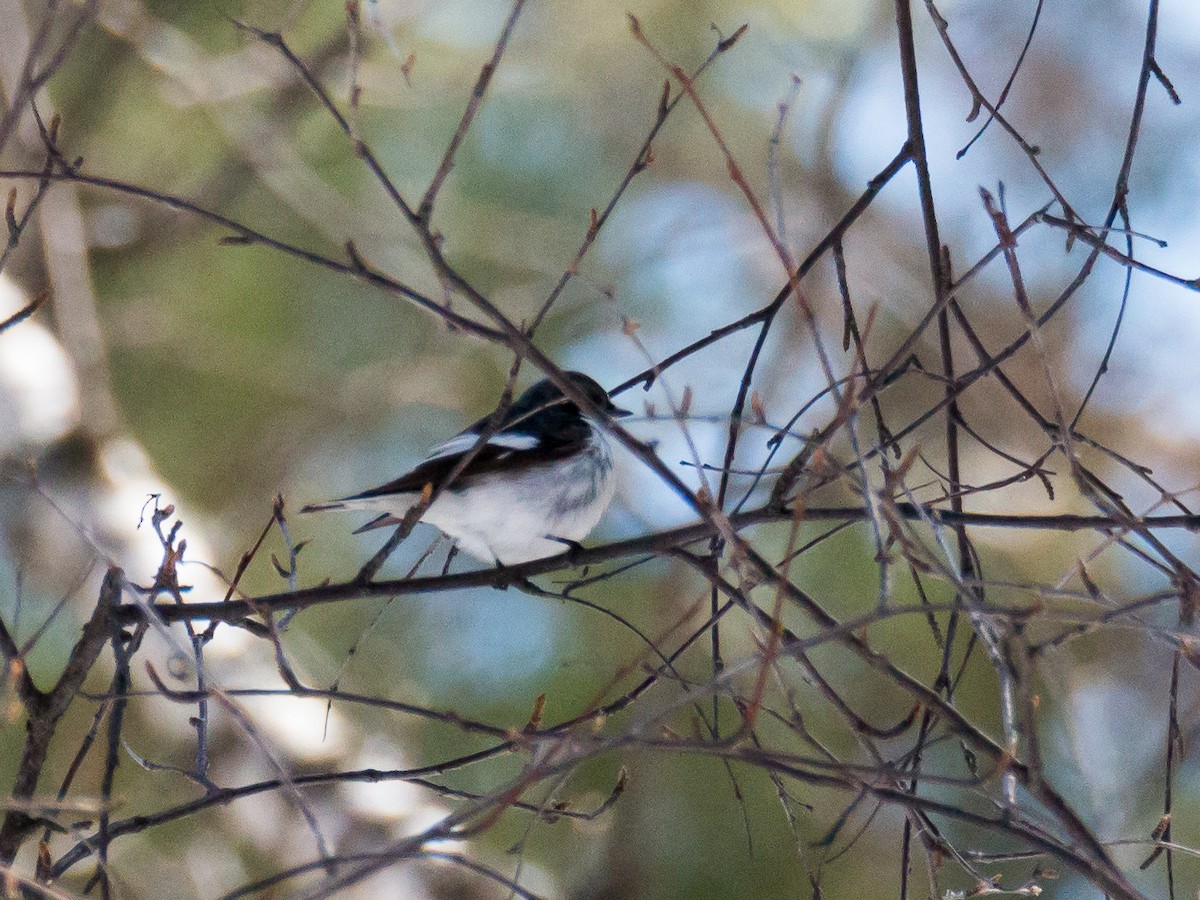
top-left (0, 0), bottom-right (1200, 898)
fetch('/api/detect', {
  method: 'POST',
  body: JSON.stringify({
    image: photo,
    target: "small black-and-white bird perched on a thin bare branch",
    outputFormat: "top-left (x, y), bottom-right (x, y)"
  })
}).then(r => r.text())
top-left (301, 372), bottom-right (630, 566)
